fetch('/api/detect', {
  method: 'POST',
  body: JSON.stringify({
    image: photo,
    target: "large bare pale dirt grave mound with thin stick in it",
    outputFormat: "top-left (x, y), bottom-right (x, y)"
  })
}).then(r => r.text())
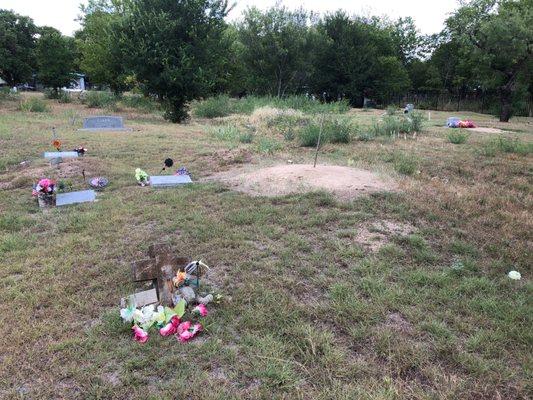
top-left (209, 164), bottom-right (396, 198)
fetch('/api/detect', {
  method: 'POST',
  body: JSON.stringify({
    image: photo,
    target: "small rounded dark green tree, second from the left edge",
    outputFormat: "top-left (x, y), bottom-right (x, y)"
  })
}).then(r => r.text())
top-left (36, 27), bottom-right (75, 95)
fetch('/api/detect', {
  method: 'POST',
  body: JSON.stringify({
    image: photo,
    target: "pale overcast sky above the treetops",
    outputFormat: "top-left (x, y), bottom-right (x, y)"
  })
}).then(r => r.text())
top-left (0, 0), bottom-right (458, 35)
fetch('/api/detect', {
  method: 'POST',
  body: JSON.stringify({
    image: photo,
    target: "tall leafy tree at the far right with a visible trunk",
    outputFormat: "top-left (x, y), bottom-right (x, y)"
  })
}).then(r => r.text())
top-left (446, 0), bottom-right (533, 122)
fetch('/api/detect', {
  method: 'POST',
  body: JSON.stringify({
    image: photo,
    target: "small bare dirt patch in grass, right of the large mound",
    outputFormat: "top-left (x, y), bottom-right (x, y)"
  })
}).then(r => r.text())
top-left (355, 220), bottom-right (415, 252)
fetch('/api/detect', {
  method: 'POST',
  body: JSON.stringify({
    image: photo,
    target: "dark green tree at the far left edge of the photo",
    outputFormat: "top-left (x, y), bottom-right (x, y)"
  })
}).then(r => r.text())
top-left (0, 9), bottom-right (37, 86)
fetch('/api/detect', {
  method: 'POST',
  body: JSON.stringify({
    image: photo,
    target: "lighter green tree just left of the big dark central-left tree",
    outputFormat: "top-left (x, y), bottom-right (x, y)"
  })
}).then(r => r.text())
top-left (76, 0), bottom-right (130, 94)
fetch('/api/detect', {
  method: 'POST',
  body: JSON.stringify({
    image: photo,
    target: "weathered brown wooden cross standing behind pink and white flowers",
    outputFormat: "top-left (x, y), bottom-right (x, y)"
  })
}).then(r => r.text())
top-left (131, 244), bottom-right (189, 307)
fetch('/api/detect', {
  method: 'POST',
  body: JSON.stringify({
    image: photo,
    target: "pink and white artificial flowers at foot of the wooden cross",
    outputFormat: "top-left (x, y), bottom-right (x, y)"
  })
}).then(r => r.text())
top-left (120, 297), bottom-right (208, 343)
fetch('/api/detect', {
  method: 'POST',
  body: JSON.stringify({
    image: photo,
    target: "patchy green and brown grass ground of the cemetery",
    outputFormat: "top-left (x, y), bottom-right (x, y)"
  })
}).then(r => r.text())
top-left (0, 93), bottom-right (533, 400)
